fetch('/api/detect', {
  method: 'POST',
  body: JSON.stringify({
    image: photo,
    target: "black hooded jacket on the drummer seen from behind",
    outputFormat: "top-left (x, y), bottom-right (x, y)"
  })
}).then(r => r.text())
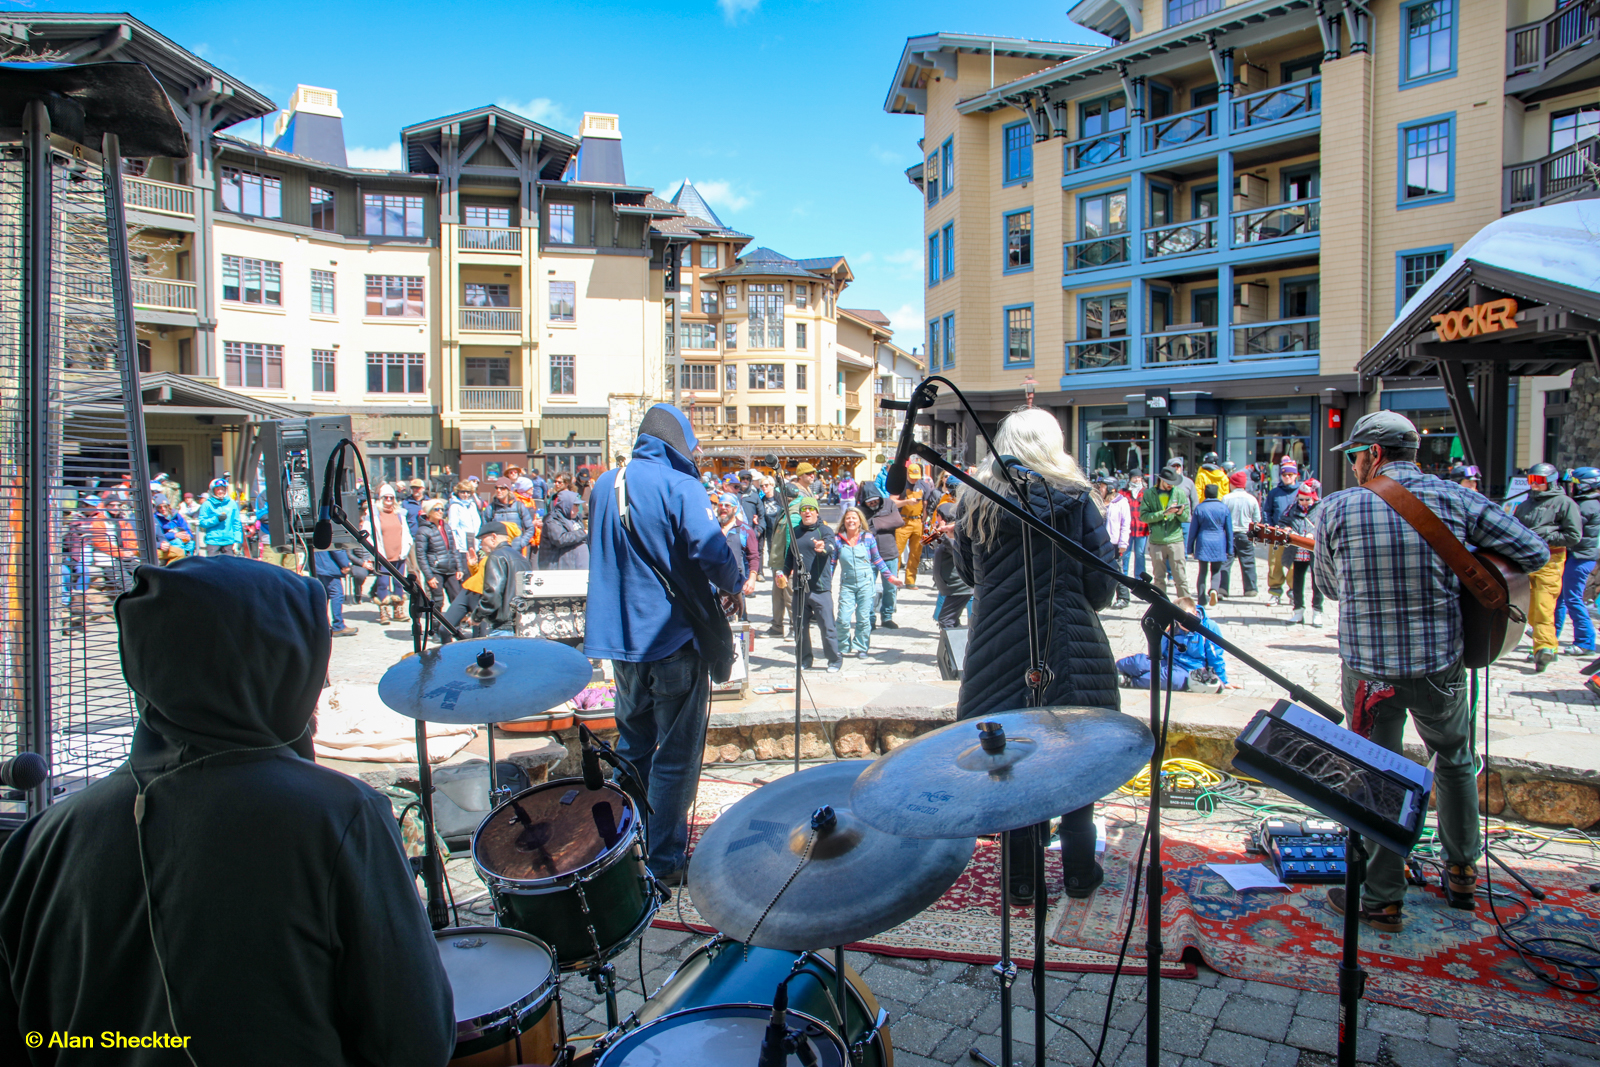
top-left (0, 557), bottom-right (456, 1067)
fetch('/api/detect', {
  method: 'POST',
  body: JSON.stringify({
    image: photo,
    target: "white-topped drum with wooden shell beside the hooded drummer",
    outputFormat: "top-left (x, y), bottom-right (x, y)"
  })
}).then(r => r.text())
top-left (434, 926), bottom-right (566, 1067)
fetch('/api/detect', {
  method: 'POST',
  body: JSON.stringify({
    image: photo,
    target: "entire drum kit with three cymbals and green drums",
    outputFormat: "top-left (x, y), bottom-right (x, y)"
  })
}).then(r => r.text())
top-left (379, 638), bottom-right (1155, 1067)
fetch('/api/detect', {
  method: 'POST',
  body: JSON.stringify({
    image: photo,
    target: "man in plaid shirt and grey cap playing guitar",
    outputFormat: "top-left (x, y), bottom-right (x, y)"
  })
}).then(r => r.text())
top-left (1312, 411), bottom-right (1549, 933)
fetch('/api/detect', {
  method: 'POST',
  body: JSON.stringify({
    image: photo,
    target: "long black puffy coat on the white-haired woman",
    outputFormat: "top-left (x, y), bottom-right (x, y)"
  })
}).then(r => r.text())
top-left (955, 482), bottom-right (1122, 718)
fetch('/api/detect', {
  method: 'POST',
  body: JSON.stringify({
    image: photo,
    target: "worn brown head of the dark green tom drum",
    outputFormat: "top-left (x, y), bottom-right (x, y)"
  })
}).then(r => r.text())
top-left (472, 777), bottom-right (634, 881)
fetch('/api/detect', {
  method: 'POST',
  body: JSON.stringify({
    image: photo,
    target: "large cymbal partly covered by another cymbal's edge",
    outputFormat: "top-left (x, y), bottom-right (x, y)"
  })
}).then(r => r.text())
top-left (688, 760), bottom-right (978, 952)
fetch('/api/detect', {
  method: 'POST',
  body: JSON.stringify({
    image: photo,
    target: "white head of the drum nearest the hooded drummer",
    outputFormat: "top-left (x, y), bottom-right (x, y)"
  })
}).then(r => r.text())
top-left (434, 926), bottom-right (555, 1025)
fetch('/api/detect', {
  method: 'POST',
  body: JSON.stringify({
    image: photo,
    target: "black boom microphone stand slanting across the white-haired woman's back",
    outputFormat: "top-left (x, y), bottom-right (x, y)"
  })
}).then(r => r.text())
top-left (912, 376), bottom-right (1344, 1067)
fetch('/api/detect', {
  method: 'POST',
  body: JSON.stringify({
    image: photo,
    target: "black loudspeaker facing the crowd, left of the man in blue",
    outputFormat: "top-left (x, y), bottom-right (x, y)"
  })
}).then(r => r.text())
top-left (256, 414), bottom-right (362, 547)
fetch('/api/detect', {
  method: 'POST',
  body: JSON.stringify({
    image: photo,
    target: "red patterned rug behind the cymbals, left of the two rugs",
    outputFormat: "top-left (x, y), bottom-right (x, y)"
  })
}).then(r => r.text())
top-left (654, 781), bottom-right (1195, 977)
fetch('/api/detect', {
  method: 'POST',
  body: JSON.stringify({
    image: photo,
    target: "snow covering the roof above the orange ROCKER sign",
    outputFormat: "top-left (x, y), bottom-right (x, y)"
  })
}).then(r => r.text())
top-left (1384, 200), bottom-right (1600, 338)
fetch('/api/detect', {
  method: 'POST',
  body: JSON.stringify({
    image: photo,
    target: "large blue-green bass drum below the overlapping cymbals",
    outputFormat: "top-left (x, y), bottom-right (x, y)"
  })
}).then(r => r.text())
top-left (614, 936), bottom-right (894, 1067)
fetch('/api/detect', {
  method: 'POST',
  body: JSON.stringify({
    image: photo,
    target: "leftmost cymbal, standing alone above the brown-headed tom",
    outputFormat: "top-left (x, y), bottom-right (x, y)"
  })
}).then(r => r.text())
top-left (378, 637), bottom-right (594, 723)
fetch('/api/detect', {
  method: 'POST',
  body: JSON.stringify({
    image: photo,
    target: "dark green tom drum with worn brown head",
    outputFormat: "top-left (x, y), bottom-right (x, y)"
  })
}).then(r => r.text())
top-left (472, 777), bottom-right (661, 971)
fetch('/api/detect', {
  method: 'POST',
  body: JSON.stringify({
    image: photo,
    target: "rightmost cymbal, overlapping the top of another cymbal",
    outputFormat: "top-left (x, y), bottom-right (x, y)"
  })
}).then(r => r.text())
top-left (850, 707), bottom-right (1155, 838)
